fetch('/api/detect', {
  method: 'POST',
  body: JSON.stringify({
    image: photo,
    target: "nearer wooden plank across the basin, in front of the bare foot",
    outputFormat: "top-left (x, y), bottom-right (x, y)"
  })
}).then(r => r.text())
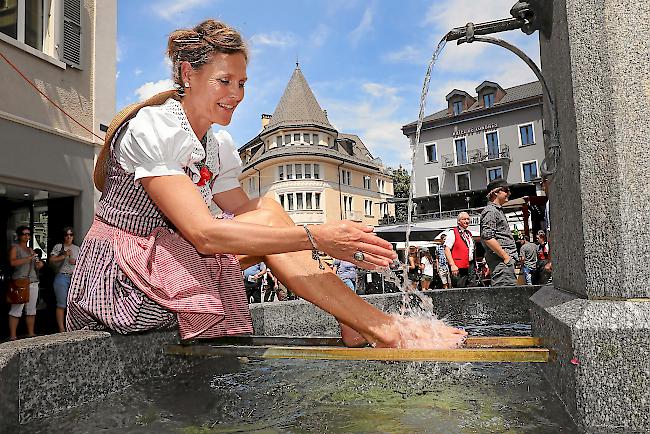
top-left (166, 345), bottom-right (549, 363)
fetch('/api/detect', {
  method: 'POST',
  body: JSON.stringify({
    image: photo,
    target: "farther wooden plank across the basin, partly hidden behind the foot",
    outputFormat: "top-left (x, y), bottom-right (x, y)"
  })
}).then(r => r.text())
top-left (183, 336), bottom-right (542, 348)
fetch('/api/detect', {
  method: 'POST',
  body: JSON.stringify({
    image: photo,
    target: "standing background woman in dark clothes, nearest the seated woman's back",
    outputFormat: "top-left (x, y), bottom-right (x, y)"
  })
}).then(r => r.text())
top-left (49, 226), bottom-right (79, 333)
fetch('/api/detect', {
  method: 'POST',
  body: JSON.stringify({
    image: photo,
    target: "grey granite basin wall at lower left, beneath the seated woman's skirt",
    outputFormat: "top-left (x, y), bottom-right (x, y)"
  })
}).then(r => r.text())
top-left (0, 331), bottom-right (193, 433)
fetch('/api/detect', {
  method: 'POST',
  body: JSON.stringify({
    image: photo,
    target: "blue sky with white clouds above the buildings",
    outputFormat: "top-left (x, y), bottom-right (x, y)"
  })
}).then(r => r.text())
top-left (116, 0), bottom-right (539, 167)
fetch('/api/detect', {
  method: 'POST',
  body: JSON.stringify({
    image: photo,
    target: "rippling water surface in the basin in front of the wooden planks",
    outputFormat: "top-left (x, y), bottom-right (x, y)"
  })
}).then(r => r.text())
top-left (23, 344), bottom-right (580, 434)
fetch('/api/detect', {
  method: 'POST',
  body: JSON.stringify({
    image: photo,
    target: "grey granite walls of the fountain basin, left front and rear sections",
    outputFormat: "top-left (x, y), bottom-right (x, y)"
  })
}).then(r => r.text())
top-left (0, 286), bottom-right (539, 432)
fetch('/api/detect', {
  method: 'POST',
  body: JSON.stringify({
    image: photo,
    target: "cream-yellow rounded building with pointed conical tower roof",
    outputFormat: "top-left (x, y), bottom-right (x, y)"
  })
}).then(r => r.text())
top-left (239, 65), bottom-right (395, 225)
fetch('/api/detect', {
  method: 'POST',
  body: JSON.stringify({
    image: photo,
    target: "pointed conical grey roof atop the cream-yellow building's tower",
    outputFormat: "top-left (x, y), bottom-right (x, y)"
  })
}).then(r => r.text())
top-left (267, 63), bottom-right (334, 129)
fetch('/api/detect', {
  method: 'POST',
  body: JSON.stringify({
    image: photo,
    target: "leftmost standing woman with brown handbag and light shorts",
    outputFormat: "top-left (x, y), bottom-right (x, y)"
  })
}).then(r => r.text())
top-left (7, 226), bottom-right (43, 341)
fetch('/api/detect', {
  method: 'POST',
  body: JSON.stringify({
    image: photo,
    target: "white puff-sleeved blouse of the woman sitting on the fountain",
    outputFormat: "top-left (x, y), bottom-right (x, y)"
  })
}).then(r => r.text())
top-left (117, 98), bottom-right (241, 204)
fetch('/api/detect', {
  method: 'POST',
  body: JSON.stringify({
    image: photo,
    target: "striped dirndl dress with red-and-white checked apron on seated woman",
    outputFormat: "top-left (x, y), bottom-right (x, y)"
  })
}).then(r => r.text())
top-left (66, 118), bottom-right (253, 339)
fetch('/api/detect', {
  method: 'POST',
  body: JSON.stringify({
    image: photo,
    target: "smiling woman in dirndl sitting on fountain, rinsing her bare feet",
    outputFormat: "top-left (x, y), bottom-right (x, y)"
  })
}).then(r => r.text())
top-left (67, 20), bottom-right (465, 347)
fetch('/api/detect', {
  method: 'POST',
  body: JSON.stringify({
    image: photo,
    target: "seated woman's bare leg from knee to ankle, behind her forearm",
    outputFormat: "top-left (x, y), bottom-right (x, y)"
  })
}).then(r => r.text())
top-left (235, 198), bottom-right (382, 346)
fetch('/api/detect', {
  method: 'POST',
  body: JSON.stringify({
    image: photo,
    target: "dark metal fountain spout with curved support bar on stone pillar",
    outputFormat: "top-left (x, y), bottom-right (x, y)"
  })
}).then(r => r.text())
top-left (444, 0), bottom-right (561, 175)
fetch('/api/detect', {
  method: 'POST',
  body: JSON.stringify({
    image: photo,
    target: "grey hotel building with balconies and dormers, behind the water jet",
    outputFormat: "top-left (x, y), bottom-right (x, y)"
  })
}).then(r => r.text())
top-left (402, 81), bottom-right (544, 217)
